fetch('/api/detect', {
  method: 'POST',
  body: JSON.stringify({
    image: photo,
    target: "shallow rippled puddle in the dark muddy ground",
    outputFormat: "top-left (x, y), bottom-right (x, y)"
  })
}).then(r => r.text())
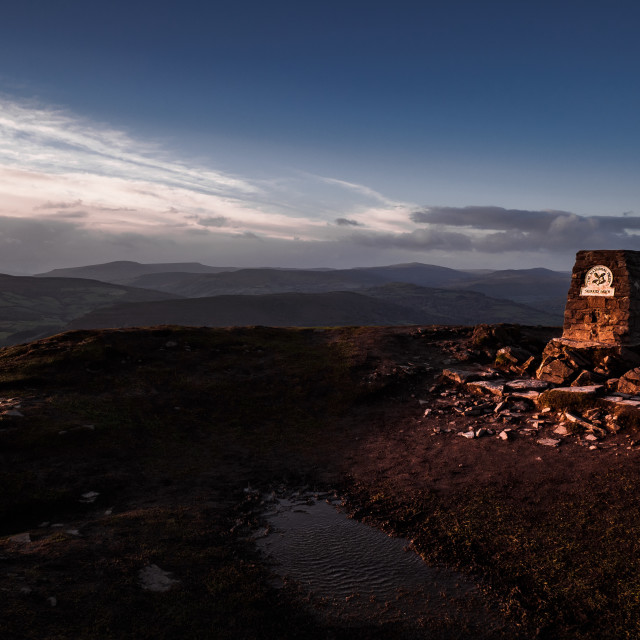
top-left (256, 496), bottom-right (492, 637)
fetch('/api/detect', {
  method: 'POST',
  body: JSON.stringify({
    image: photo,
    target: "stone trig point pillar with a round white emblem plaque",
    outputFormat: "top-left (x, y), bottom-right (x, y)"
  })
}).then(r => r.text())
top-left (562, 250), bottom-right (640, 346)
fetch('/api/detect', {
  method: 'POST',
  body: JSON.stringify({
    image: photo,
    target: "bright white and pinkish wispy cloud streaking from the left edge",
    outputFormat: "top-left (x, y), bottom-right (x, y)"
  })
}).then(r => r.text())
top-left (0, 97), bottom-right (410, 268)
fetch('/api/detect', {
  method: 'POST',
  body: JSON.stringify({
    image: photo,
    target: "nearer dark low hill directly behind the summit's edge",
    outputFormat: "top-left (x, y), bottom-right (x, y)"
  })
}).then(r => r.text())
top-left (66, 284), bottom-right (558, 336)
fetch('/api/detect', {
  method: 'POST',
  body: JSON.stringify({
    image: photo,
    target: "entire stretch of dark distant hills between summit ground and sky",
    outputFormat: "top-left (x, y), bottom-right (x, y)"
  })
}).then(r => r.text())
top-left (0, 261), bottom-right (570, 345)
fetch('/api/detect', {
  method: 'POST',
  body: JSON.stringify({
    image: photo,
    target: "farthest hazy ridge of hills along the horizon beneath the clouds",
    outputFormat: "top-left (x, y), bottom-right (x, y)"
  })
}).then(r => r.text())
top-left (39, 262), bottom-right (571, 315)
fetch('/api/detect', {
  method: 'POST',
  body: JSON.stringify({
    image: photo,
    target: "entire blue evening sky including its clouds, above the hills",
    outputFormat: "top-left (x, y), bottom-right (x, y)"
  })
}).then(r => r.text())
top-left (0, 0), bottom-right (640, 274)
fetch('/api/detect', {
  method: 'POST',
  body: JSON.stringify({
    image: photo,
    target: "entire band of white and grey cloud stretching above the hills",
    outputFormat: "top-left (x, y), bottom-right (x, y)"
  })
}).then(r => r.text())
top-left (0, 98), bottom-right (640, 272)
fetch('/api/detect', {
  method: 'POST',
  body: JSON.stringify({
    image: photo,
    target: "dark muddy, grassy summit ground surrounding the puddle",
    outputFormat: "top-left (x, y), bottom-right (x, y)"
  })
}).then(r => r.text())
top-left (0, 327), bottom-right (640, 638)
